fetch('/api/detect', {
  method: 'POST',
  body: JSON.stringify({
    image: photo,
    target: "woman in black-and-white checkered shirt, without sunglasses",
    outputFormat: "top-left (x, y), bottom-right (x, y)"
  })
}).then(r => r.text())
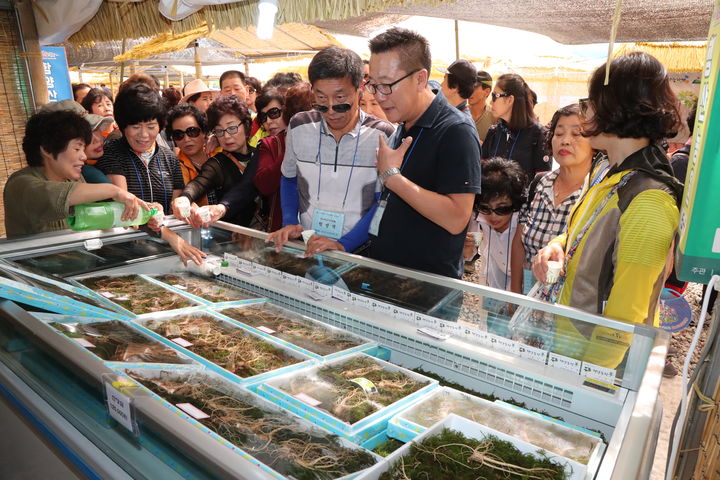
top-left (511, 104), bottom-right (594, 294)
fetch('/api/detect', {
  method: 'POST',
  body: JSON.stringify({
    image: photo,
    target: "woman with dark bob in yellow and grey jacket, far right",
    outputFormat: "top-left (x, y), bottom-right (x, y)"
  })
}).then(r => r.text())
top-left (533, 52), bottom-right (682, 368)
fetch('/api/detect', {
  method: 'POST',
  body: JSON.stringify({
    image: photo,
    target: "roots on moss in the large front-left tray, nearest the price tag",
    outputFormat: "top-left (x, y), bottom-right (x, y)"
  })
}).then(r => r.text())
top-left (130, 372), bottom-right (375, 480)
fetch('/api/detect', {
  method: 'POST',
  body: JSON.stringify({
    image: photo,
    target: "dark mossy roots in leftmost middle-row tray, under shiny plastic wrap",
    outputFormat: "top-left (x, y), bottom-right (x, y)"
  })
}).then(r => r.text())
top-left (49, 320), bottom-right (190, 363)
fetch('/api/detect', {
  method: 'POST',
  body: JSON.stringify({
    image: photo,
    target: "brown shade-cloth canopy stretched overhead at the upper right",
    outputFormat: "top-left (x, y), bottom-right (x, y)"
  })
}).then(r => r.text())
top-left (313, 0), bottom-right (714, 44)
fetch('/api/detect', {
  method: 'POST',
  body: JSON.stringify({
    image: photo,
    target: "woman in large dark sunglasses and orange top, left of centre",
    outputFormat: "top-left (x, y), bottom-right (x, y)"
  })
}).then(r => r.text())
top-left (165, 103), bottom-right (208, 206)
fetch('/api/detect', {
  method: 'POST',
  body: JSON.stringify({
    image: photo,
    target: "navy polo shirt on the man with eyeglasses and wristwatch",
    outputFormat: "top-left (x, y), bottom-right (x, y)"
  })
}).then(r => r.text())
top-left (369, 95), bottom-right (480, 278)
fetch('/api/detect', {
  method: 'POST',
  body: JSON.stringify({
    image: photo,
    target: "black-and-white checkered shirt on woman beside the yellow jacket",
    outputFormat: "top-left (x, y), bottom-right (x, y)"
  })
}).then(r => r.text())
top-left (520, 170), bottom-right (583, 268)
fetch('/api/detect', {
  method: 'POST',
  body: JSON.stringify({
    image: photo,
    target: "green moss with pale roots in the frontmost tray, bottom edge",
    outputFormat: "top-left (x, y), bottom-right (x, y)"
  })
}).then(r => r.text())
top-left (380, 428), bottom-right (567, 480)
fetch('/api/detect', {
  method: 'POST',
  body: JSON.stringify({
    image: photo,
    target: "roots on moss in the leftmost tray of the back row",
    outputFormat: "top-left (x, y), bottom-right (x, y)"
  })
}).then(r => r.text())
top-left (80, 275), bottom-right (194, 315)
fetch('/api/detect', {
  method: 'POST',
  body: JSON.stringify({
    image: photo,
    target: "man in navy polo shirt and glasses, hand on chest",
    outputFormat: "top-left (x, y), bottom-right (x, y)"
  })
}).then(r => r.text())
top-left (366, 28), bottom-right (480, 278)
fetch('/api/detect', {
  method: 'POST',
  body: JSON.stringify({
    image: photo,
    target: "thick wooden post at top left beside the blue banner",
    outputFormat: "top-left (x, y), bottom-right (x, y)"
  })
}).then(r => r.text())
top-left (15, 0), bottom-right (50, 108)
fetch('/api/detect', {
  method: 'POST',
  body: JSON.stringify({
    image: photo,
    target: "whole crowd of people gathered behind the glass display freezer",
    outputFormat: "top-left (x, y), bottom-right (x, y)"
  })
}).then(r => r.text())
top-left (5, 28), bottom-right (692, 368)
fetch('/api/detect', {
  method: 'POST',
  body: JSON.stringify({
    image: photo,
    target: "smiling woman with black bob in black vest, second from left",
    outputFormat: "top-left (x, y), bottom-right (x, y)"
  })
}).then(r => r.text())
top-left (97, 83), bottom-right (184, 212)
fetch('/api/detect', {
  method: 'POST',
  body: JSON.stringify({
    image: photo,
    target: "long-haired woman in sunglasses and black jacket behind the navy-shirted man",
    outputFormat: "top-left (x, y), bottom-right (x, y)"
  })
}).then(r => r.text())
top-left (481, 73), bottom-right (550, 181)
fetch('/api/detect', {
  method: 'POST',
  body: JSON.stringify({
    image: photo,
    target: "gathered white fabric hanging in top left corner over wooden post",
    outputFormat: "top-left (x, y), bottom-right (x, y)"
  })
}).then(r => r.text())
top-left (33, 0), bottom-right (102, 45)
